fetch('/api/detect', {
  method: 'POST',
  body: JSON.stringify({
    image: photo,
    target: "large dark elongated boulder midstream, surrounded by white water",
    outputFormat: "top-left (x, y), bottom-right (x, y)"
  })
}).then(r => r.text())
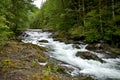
top-left (76, 52), bottom-right (105, 63)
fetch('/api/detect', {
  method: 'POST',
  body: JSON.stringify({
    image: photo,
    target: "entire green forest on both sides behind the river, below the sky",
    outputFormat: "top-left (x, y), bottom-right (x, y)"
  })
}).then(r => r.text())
top-left (0, 0), bottom-right (120, 47)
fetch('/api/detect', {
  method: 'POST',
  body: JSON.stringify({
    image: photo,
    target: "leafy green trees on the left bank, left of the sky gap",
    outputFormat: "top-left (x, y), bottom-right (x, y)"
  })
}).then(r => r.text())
top-left (0, 0), bottom-right (37, 44)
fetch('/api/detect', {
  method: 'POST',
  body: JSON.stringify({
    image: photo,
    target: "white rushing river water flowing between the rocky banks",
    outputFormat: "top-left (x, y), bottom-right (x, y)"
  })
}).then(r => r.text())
top-left (22, 30), bottom-right (120, 80)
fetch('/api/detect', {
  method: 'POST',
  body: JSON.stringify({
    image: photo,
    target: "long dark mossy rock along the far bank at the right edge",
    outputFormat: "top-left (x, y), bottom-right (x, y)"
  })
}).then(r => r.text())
top-left (86, 43), bottom-right (120, 58)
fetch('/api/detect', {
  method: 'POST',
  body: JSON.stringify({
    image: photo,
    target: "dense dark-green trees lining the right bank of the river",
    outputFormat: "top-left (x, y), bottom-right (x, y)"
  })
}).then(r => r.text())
top-left (31, 0), bottom-right (120, 47)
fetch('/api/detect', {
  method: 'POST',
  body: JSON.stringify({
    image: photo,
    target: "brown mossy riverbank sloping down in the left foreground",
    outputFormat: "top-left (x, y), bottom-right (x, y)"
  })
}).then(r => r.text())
top-left (0, 41), bottom-right (91, 80)
